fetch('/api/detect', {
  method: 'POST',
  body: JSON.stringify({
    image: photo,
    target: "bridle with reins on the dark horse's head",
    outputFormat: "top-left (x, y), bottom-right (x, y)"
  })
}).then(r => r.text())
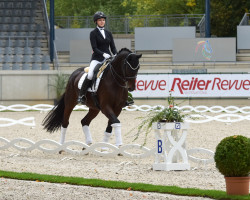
top-left (109, 53), bottom-right (140, 88)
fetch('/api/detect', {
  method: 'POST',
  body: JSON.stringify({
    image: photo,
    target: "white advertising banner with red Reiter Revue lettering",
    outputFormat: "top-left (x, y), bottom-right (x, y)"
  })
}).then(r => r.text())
top-left (132, 74), bottom-right (250, 98)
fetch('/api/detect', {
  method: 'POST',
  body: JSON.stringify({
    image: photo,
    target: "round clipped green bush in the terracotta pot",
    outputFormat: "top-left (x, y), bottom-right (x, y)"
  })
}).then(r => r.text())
top-left (214, 135), bottom-right (250, 177)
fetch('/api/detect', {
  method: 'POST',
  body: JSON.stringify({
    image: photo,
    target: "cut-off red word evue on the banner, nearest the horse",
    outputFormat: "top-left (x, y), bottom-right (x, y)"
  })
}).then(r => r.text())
top-left (136, 80), bottom-right (167, 91)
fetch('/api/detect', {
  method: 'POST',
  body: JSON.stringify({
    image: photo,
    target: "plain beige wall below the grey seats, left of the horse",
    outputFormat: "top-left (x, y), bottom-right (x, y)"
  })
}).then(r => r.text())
top-left (0, 71), bottom-right (71, 105)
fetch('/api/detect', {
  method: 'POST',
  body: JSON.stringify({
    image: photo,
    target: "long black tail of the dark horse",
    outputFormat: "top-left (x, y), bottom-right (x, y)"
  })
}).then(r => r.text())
top-left (42, 93), bottom-right (65, 133)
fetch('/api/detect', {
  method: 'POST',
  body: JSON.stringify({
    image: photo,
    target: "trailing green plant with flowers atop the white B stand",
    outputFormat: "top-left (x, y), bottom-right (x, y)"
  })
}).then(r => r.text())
top-left (134, 90), bottom-right (188, 144)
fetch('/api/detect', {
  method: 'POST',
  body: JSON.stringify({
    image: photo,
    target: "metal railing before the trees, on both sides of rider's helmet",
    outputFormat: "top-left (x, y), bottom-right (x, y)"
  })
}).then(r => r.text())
top-left (55, 14), bottom-right (204, 34)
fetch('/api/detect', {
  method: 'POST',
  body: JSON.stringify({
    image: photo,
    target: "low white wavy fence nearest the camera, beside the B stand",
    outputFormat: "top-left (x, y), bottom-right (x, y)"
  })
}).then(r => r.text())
top-left (0, 137), bottom-right (214, 165)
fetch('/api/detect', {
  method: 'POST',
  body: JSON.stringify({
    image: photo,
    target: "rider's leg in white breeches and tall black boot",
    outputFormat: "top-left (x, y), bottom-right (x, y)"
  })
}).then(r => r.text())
top-left (78, 60), bottom-right (100, 104)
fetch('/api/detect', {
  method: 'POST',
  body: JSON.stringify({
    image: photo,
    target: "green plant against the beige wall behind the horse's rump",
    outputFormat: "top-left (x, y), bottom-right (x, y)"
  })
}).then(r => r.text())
top-left (50, 72), bottom-right (69, 100)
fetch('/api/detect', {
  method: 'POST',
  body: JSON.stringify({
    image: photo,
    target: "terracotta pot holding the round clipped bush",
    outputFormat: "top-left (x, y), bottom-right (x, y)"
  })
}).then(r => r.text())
top-left (225, 176), bottom-right (250, 195)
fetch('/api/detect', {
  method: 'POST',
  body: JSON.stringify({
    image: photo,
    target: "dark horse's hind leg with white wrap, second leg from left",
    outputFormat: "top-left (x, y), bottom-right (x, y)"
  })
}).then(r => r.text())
top-left (81, 108), bottom-right (100, 145)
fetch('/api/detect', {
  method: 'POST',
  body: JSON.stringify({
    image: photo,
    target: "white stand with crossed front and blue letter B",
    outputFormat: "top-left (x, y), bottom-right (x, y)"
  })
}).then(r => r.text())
top-left (152, 122), bottom-right (190, 171)
